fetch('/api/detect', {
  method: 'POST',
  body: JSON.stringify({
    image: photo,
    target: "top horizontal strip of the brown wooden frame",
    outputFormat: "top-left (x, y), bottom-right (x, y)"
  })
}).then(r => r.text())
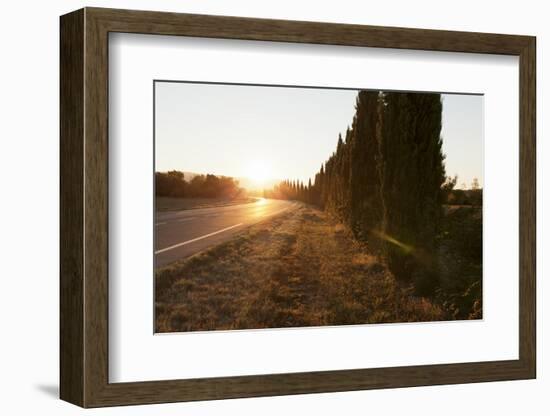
top-left (90, 8), bottom-right (529, 55)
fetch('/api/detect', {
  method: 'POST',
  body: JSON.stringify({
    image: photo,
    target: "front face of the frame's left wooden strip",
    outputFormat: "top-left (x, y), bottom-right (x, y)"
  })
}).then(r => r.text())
top-left (84, 10), bottom-right (109, 406)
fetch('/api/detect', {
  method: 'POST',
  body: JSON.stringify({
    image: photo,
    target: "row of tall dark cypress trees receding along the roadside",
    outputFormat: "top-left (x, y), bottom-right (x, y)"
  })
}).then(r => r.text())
top-left (282, 91), bottom-right (445, 295)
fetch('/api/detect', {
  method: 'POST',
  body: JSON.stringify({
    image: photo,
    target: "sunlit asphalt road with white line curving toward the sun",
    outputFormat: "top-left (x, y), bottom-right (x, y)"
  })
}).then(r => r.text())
top-left (155, 199), bottom-right (298, 268)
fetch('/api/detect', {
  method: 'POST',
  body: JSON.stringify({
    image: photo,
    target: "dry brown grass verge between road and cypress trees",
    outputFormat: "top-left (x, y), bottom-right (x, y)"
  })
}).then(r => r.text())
top-left (156, 207), bottom-right (448, 332)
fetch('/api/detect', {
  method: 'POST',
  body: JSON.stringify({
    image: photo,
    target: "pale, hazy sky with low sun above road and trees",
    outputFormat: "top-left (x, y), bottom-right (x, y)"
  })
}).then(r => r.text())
top-left (155, 82), bottom-right (483, 186)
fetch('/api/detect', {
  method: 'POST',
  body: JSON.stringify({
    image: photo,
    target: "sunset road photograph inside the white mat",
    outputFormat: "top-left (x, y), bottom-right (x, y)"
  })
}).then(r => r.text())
top-left (151, 80), bottom-right (484, 333)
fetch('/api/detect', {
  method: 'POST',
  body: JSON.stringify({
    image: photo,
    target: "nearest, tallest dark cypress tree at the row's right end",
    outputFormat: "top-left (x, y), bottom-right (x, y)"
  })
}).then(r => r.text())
top-left (378, 93), bottom-right (445, 294)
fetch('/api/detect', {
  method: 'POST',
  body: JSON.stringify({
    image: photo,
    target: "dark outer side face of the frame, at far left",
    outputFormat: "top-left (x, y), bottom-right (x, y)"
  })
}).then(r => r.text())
top-left (59, 10), bottom-right (85, 406)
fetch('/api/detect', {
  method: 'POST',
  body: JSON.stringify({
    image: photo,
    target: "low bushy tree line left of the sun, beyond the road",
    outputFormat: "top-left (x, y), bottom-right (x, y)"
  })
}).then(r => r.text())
top-left (155, 170), bottom-right (242, 198)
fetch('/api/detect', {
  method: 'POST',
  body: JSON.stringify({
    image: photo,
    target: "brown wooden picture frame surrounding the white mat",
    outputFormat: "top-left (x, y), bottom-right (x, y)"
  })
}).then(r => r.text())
top-left (60, 8), bottom-right (536, 407)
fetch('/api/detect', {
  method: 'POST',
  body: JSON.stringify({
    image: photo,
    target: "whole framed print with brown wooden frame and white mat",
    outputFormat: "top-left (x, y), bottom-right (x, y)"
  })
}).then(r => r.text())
top-left (60, 8), bottom-right (536, 407)
